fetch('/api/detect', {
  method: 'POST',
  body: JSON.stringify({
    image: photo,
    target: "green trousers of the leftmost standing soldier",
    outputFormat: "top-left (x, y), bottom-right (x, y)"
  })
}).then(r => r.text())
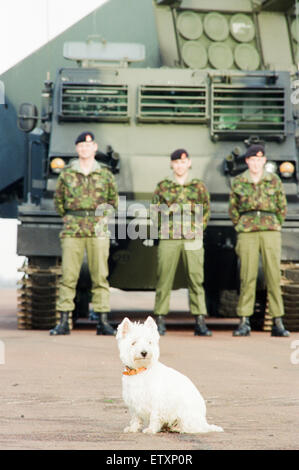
top-left (56, 237), bottom-right (110, 313)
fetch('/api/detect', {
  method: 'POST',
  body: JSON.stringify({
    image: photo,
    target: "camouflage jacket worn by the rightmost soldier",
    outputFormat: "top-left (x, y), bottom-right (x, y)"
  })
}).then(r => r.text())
top-left (229, 170), bottom-right (287, 232)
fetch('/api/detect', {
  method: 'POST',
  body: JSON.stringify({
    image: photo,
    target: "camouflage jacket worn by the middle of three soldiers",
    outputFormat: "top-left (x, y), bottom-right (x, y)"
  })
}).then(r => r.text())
top-left (151, 173), bottom-right (210, 240)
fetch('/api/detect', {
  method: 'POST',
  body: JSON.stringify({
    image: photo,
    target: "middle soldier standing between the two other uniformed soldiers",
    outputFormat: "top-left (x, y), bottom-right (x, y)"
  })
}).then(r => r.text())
top-left (152, 149), bottom-right (212, 336)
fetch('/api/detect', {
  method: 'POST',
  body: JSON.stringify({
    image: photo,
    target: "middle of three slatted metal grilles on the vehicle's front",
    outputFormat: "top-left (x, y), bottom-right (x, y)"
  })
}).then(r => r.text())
top-left (138, 85), bottom-right (207, 122)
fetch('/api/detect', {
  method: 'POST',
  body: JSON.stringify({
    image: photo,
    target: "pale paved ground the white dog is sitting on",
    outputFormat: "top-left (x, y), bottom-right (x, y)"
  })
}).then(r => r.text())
top-left (0, 290), bottom-right (299, 451)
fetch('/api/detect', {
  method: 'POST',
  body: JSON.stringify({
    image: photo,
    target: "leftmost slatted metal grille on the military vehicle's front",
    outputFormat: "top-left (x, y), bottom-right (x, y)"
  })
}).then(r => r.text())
top-left (59, 83), bottom-right (129, 121)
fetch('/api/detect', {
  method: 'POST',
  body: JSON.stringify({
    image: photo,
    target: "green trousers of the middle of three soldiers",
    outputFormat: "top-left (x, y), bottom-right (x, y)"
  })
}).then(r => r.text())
top-left (154, 240), bottom-right (207, 315)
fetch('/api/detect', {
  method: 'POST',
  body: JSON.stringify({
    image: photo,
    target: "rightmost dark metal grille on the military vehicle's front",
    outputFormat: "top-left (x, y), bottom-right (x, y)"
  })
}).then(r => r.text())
top-left (211, 85), bottom-right (286, 138)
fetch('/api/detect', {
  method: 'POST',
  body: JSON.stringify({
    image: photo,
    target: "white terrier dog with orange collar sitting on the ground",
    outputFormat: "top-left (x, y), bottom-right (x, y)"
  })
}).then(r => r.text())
top-left (116, 317), bottom-right (223, 434)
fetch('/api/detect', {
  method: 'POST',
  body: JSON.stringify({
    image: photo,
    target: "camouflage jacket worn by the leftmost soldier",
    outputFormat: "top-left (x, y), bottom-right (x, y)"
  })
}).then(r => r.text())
top-left (54, 159), bottom-right (118, 238)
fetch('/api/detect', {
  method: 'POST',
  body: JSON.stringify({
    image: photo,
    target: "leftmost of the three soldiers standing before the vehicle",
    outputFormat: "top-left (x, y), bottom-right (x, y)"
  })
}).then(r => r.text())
top-left (50, 132), bottom-right (118, 335)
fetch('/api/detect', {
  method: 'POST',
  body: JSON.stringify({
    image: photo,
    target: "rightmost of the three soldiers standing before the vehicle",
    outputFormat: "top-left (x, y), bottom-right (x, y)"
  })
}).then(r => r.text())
top-left (229, 144), bottom-right (289, 336)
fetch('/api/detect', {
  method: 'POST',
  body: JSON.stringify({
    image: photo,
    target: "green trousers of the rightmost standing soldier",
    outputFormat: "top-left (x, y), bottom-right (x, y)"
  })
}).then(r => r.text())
top-left (236, 231), bottom-right (284, 317)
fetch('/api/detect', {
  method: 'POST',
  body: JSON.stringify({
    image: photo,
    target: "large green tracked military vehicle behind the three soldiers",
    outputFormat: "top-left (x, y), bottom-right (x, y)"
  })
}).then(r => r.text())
top-left (17, 0), bottom-right (299, 330)
